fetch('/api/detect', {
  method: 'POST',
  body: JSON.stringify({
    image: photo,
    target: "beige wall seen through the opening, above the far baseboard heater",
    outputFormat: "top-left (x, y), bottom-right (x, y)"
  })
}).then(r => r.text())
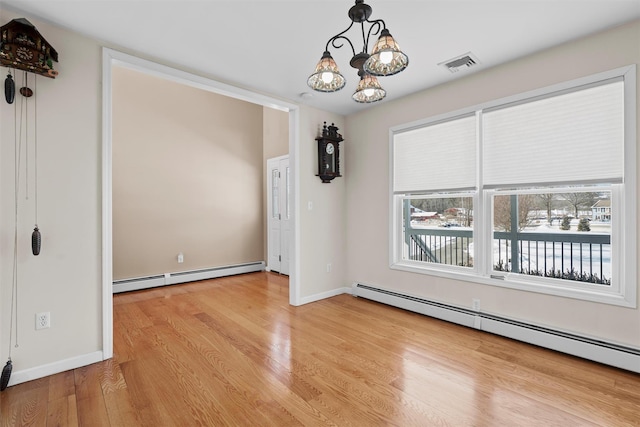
top-left (113, 67), bottom-right (265, 280)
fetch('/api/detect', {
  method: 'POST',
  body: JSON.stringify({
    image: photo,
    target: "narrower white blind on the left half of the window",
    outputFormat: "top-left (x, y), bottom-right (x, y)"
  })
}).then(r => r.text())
top-left (393, 115), bottom-right (476, 193)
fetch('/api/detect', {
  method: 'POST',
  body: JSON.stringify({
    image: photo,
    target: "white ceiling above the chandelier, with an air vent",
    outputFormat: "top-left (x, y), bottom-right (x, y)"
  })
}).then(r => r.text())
top-left (0, 0), bottom-right (640, 115)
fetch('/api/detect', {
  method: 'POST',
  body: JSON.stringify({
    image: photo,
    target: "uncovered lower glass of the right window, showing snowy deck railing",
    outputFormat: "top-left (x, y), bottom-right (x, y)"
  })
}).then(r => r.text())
top-left (491, 186), bottom-right (612, 287)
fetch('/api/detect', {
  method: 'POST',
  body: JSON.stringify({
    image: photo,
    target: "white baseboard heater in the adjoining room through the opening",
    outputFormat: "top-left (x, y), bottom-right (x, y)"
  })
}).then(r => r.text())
top-left (112, 261), bottom-right (265, 294)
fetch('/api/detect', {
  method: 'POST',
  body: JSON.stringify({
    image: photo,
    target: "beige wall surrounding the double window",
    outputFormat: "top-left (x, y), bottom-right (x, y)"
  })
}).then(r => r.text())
top-left (346, 21), bottom-right (640, 348)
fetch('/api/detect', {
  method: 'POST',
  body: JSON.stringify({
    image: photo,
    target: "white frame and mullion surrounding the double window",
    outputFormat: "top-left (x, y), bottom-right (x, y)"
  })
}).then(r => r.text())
top-left (389, 64), bottom-right (637, 308)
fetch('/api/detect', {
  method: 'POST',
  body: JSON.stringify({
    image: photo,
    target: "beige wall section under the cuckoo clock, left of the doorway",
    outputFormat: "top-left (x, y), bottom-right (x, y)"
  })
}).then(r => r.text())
top-left (0, 10), bottom-right (102, 374)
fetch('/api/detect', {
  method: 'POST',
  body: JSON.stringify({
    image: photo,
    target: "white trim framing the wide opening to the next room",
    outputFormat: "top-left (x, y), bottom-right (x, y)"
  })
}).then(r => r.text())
top-left (102, 47), bottom-right (301, 360)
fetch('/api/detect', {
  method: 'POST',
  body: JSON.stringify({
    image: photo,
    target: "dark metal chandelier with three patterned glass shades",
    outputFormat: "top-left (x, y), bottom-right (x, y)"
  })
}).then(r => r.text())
top-left (307, 0), bottom-right (409, 103)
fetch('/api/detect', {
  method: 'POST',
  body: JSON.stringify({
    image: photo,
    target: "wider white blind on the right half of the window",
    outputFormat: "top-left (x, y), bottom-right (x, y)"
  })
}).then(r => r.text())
top-left (482, 80), bottom-right (624, 186)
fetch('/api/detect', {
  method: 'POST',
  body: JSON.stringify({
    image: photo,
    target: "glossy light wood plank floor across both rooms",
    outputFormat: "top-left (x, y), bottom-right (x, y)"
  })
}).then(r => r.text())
top-left (0, 273), bottom-right (640, 427)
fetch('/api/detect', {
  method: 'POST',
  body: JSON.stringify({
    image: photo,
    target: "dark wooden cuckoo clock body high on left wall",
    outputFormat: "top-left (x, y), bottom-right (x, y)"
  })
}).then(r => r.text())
top-left (0, 18), bottom-right (58, 78)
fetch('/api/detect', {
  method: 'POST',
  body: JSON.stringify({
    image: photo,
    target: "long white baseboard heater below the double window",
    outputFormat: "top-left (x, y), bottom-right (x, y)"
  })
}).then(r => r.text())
top-left (352, 283), bottom-right (640, 373)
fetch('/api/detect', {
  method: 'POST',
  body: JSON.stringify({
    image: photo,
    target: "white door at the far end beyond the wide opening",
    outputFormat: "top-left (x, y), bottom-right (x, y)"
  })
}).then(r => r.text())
top-left (267, 156), bottom-right (291, 275)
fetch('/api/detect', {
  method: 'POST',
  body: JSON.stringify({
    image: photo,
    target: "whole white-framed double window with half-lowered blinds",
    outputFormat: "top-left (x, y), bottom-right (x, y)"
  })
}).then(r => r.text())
top-left (391, 66), bottom-right (636, 306)
